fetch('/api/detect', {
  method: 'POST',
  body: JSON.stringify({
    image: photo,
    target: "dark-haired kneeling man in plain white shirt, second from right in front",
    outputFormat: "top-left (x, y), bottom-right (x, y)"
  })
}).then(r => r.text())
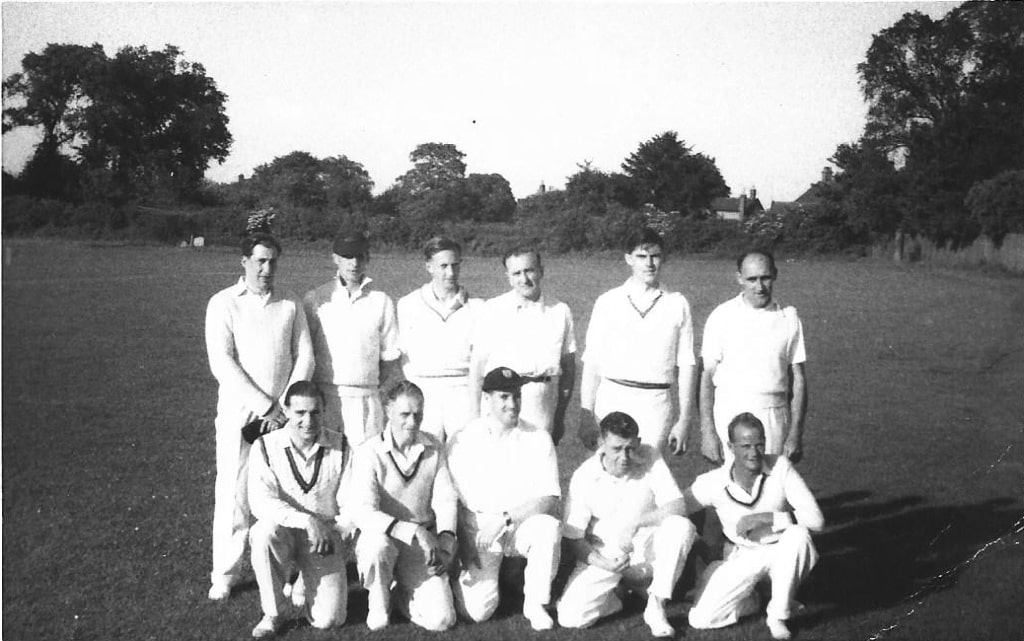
top-left (558, 412), bottom-right (697, 637)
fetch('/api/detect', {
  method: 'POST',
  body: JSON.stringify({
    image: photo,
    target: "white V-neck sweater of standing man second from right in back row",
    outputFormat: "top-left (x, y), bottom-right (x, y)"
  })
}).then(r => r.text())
top-left (583, 280), bottom-right (695, 384)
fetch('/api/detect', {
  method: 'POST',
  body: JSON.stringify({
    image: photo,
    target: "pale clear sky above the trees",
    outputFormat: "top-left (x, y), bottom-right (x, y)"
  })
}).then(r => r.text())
top-left (2, 1), bottom-right (957, 200)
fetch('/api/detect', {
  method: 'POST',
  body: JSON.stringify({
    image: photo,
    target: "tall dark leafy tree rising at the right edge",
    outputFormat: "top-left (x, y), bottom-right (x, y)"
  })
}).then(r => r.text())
top-left (857, 2), bottom-right (1024, 245)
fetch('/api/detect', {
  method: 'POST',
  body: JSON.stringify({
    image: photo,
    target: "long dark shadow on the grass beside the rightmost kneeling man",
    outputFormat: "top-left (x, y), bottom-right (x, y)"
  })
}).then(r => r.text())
top-left (801, 493), bottom-right (1020, 625)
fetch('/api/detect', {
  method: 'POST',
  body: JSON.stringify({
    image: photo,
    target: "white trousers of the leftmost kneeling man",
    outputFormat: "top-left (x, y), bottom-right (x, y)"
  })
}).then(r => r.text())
top-left (251, 520), bottom-right (350, 628)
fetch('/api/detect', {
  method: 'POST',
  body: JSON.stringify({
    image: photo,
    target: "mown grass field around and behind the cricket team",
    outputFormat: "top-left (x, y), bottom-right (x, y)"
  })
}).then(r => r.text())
top-left (2, 240), bottom-right (1024, 641)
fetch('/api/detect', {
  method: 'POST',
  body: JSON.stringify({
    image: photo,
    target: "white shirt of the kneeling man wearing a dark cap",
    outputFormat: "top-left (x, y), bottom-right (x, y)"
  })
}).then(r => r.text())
top-left (447, 417), bottom-right (561, 514)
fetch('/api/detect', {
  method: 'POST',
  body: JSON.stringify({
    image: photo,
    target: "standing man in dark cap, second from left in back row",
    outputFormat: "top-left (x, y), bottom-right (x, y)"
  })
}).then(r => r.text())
top-left (305, 229), bottom-right (400, 444)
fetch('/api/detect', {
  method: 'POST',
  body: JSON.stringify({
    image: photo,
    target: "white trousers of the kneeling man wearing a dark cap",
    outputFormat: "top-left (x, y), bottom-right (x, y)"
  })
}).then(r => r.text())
top-left (453, 514), bottom-right (561, 622)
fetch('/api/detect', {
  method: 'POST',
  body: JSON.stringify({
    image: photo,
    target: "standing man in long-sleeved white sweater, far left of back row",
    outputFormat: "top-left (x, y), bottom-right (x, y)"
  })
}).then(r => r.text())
top-left (200, 232), bottom-right (313, 601)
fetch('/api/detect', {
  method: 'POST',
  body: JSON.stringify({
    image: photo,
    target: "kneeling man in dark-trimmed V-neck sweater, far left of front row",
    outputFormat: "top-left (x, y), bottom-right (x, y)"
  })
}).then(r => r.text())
top-left (249, 381), bottom-right (355, 639)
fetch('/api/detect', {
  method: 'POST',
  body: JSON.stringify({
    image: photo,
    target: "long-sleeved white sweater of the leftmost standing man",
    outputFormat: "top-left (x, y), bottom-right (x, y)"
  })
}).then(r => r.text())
top-left (206, 279), bottom-right (313, 416)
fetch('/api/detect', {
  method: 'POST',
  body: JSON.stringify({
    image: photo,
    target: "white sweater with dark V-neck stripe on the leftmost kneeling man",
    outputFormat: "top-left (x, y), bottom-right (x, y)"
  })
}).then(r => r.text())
top-left (249, 427), bottom-right (352, 529)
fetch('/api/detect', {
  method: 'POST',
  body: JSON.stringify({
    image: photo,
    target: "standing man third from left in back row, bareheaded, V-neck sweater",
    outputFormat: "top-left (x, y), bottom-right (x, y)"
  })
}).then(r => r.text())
top-left (398, 237), bottom-right (483, 442)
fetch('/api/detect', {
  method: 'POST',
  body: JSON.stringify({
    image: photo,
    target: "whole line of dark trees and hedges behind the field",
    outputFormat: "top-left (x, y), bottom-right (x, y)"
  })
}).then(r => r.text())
top-left (3, 2), bottom-right (1024, 257)
